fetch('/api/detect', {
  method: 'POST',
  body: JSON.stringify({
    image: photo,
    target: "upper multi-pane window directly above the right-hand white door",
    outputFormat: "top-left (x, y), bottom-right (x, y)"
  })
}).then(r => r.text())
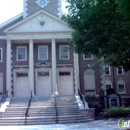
top-left (59, 45), bottom-right (69, 60)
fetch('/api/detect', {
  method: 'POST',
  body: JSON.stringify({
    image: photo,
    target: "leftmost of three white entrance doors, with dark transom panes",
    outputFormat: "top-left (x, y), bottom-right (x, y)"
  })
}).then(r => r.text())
top-left (15, 72), bottom-right (30, 97)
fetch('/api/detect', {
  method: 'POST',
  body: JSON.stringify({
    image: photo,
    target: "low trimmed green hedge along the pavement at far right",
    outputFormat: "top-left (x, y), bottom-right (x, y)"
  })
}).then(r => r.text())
top-left (105, 107), bottom-right (130, 117)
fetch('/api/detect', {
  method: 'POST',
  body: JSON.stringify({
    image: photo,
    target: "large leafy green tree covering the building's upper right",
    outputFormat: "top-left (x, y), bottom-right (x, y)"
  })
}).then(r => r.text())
top-left (62, 0), bottom-right (130, 71)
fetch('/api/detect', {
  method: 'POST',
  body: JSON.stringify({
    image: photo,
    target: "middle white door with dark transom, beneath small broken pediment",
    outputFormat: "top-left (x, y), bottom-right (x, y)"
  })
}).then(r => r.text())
top-left (36, 71), bottom-right (52, 97)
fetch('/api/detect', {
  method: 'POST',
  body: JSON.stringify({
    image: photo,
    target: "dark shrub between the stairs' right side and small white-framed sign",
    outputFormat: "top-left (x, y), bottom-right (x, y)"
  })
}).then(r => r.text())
top-left (85, 95), bottom-right (102, 114)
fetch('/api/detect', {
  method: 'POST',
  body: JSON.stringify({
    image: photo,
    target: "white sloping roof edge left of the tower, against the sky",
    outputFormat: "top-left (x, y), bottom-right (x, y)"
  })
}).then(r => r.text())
top-left (0, 13), bottom-right (23, 29)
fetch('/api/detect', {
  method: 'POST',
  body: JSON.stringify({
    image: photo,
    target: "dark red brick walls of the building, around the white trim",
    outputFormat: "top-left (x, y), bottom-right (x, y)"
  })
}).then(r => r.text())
top-left (0, 0), bottom-right (130, 106)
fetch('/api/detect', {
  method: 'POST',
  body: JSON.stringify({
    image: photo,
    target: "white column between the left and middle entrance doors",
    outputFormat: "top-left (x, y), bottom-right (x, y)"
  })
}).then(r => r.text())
top-left (29, 39), bottom-right (34, 95)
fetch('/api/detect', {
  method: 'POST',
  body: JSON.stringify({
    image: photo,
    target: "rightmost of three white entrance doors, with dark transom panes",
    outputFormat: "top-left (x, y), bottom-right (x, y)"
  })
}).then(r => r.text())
top-left (58, 71), bottom-right (74, 95)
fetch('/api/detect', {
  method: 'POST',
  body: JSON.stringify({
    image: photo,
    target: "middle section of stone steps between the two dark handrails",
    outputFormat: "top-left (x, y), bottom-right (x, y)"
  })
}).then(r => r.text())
top-left (26, 98), bottom-right (56, 125)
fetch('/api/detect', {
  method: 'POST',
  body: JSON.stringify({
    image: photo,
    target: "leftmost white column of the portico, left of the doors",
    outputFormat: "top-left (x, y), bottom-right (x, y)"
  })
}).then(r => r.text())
top-left (6, 40), bottom-right (11, 97)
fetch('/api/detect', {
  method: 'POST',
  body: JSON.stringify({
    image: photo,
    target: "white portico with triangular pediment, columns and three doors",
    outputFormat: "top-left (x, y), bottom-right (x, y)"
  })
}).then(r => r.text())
top-left (5, 11), bottom-right (79, 97)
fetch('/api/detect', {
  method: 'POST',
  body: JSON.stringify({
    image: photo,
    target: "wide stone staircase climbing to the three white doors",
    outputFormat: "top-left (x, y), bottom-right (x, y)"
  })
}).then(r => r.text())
top-left (0, 96), bottom-right (93, 126)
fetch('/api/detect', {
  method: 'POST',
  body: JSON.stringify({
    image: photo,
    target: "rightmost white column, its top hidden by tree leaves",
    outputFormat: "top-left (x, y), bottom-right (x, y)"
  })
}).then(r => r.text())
top-left (74, 53), bottom-right (79, 95)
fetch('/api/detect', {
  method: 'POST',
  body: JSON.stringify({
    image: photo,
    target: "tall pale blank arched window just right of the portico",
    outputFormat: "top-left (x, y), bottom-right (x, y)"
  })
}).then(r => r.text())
top-left (84, 69), bottom-right (95, 92)
